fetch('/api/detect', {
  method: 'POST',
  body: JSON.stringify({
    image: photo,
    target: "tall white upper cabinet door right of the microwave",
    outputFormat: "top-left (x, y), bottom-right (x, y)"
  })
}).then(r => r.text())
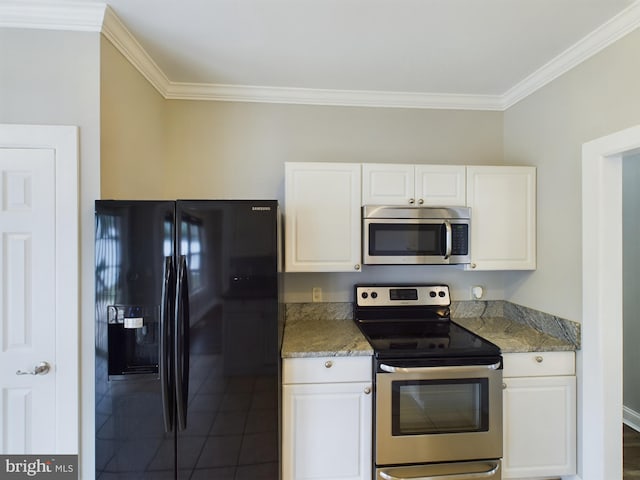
top-left (466, 166), bottom-right (536, 270)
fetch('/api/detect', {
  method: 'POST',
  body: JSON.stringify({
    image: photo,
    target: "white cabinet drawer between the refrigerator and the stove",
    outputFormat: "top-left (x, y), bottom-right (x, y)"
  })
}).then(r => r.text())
top-left (282, 356), bottom-right (373, 383)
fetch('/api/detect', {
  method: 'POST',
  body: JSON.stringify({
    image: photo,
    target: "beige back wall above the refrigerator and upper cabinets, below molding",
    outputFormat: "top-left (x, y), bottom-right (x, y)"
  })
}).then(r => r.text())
top-left (165, 101), bottom-right (502, 200)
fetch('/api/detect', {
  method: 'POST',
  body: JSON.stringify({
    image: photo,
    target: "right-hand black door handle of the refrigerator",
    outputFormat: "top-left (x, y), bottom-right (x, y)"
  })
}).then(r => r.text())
top-left (174, 255), bottom-right (189, 430)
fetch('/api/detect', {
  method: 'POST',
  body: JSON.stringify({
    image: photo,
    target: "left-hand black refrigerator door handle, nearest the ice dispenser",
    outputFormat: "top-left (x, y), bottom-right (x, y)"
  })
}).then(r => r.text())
top-left (159, 257), bottom-right (175, 433)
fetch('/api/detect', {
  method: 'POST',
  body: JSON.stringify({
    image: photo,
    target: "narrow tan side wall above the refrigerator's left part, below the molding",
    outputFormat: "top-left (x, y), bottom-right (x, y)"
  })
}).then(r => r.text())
top-left (100, 37), bottom-right (166, 199)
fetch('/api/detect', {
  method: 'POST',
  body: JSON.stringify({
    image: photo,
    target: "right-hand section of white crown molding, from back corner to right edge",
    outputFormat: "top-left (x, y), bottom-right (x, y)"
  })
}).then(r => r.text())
top-left (502, 0), bottom-right (640, 110)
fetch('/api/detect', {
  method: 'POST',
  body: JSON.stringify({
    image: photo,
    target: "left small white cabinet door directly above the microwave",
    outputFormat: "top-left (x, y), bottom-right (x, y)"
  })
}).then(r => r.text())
top-left (362, 163), bottom-right (416, 205)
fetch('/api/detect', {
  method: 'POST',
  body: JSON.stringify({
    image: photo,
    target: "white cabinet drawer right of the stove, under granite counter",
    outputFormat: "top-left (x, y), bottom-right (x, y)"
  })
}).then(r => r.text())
top-left (502, 352), bottom-right (576, 377)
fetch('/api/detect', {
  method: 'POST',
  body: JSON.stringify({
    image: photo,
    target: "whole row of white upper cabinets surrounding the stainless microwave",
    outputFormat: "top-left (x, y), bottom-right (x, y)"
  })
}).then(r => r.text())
top-left (284, 162), bottom-right (536, 272)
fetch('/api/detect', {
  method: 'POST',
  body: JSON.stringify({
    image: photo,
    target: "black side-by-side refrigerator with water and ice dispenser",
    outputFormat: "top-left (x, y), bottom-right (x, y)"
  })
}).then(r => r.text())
top-left (95, 200), bottom-right (283, 480)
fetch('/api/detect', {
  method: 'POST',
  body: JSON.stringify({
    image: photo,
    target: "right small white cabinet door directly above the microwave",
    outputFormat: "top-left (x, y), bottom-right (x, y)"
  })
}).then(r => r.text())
top-left (415, 165), bottom-right (467, 206)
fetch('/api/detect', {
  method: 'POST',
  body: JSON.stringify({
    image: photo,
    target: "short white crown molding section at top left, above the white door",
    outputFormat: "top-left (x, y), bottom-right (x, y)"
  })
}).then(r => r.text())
top-left (0, 0), bottom-right (106, 32)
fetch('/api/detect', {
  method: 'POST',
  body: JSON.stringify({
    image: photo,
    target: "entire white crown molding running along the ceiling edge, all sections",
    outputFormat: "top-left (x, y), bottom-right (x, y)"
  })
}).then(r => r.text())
top-left (0, 0), bottom-right (640, 111)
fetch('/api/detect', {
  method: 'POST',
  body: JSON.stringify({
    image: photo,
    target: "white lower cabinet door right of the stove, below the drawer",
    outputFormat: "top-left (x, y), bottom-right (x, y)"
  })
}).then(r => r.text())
top-left (502, 376), bottom-right (576, 478)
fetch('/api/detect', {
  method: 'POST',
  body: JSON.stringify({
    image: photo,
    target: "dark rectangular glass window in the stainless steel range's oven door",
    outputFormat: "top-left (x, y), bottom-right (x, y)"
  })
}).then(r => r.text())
top-left (391, 378), bottom-right (489, 436)
